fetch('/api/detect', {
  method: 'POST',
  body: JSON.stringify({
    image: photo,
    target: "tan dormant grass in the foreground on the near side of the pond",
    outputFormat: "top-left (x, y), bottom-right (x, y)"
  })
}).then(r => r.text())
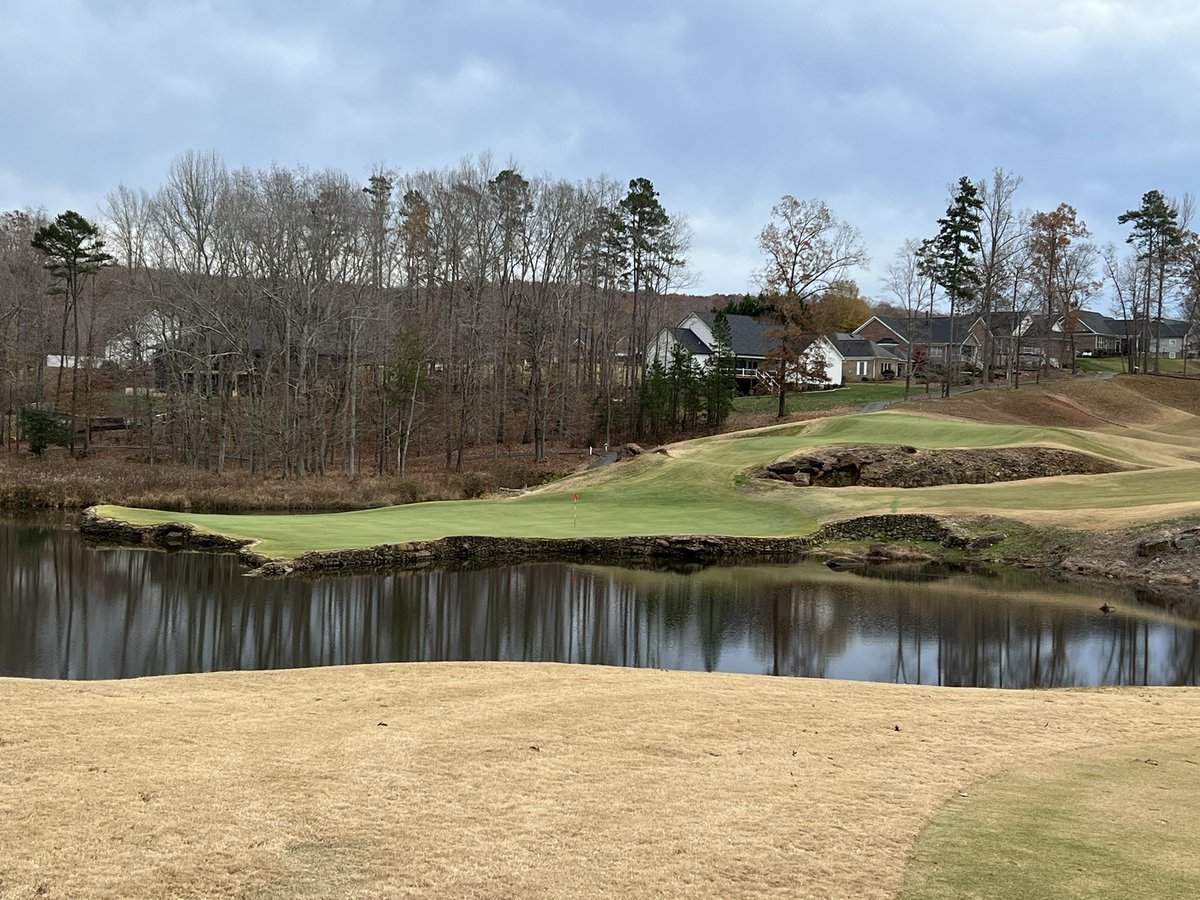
top-left (0, 664), bottom-right (1200, 899)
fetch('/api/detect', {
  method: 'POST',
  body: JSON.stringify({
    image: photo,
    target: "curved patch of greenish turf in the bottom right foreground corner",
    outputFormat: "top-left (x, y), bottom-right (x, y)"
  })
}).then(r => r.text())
top-left (901, 742), bottom-right (1200, 900)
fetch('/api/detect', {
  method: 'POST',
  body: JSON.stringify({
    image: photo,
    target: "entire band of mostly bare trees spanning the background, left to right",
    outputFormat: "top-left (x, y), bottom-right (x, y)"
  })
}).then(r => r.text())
top-left (0, 152), bottom-right (1200, 476)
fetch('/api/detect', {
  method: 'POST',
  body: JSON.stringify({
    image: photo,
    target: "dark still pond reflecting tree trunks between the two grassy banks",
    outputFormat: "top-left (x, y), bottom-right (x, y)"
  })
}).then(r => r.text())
top-left (0, 518), bottom-right (1200, 688)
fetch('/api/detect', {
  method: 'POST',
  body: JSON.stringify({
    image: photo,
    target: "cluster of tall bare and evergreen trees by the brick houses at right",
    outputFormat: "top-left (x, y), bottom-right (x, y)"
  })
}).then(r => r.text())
top-left (881, 168), bottom-right (1200, 390)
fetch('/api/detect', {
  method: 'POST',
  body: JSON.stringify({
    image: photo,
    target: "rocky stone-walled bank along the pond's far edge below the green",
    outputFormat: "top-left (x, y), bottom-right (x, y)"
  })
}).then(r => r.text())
top-left (79, 508), bottom-right (1200, 619)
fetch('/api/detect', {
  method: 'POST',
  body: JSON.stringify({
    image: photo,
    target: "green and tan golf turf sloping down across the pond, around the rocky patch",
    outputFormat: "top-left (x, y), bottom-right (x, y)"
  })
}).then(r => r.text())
top-left (97, 382), bottom-right (1200, 558)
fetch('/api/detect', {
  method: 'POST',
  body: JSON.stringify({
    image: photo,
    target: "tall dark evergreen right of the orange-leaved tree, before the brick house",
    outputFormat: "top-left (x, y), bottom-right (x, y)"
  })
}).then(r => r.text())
top-left (924, 175), bottom-right (983, 397)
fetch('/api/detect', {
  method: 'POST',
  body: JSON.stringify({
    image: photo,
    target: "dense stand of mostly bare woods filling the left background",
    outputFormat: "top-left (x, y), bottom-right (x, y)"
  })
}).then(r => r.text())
top-left (0, 154), bottom-right (689, 475)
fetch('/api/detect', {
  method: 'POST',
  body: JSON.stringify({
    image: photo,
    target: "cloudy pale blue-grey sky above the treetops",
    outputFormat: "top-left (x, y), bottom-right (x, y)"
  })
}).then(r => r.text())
top-left (0, 0), bottom-right (1200, 303)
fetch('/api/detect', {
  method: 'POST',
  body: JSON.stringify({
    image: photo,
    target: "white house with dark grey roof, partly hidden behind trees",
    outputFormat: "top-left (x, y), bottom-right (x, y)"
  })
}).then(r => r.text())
top-left (647, 312), bottom-right (844, 394)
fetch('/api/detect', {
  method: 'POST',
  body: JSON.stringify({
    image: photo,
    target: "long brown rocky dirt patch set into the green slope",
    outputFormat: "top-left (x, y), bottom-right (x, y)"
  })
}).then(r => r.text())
top-left (760, 445), bottom-right (1122, 487)
